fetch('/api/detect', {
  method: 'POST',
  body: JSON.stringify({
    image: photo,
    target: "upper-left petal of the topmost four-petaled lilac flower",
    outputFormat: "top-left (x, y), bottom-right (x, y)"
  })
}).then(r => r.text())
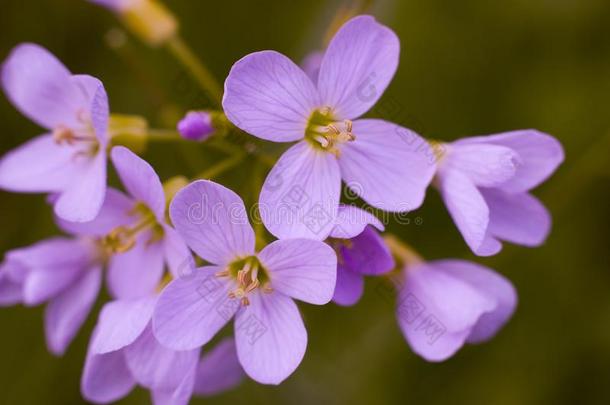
top-left (222, 51), bottom-right (319, 142)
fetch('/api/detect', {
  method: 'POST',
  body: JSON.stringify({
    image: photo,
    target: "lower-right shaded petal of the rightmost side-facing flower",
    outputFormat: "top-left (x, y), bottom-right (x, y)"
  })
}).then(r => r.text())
top-left (481, 189), bottom-right (551, 247)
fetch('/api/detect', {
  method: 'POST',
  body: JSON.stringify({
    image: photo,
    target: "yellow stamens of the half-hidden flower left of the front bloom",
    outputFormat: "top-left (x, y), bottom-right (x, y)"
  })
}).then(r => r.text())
top-left (102, 203), bottom-right (163, 254)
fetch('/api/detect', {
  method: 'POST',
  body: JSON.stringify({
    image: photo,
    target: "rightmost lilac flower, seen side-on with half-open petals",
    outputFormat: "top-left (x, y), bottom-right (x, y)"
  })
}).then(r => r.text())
top-left (435, 130), bottom-right (564, 256)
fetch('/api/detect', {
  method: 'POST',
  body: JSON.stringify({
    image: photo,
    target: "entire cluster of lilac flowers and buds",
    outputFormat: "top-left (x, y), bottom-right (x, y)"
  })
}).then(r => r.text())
top-left (0, 6), bottom-right (563, 404)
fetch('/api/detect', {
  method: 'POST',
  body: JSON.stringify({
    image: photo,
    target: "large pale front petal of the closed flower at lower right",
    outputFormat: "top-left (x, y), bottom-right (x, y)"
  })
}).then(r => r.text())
top-left (397, 263), bottom-right (498, 361)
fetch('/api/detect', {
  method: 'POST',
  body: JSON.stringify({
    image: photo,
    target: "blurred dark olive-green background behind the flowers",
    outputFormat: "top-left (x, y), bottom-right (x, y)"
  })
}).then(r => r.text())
top-left (0, 0), bottom-right (610, 405)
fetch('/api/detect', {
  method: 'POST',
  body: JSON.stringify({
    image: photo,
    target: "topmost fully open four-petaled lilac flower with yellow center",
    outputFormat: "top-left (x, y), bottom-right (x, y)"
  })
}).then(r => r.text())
top-left (223, 16), bottom-right (434, 240)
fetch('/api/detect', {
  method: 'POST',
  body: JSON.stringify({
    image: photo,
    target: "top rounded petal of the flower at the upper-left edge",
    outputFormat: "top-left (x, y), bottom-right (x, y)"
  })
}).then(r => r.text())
top-left (2, 43), bottom-right (88, 129)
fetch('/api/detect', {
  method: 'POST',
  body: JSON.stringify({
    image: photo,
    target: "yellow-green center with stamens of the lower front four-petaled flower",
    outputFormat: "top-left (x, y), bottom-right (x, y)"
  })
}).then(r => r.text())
top-left (216, 256), bottom-right (273, 306)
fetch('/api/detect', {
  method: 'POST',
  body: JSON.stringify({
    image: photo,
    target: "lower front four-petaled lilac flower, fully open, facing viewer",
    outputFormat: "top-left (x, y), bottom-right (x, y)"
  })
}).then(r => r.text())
top-left (153, 180), bottom-right (337, 384)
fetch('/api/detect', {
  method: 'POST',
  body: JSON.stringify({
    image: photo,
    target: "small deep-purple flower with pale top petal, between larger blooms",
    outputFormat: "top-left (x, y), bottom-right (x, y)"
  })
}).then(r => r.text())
top-left (327, 206), bottom-right (395, 306)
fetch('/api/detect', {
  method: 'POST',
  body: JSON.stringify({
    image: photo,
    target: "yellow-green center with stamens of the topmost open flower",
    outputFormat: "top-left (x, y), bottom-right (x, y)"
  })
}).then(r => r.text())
top-left (305, 107), bottom-right (356, 157)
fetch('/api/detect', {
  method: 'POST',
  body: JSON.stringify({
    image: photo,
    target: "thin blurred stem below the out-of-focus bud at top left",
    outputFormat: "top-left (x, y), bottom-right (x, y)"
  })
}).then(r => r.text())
top-left (167, 35), bottom-right (222, 106)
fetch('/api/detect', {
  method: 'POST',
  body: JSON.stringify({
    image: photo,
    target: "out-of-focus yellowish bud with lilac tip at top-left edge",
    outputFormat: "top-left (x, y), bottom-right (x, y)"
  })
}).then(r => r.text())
top-left (89, 0), bottom-right (178, 45)
